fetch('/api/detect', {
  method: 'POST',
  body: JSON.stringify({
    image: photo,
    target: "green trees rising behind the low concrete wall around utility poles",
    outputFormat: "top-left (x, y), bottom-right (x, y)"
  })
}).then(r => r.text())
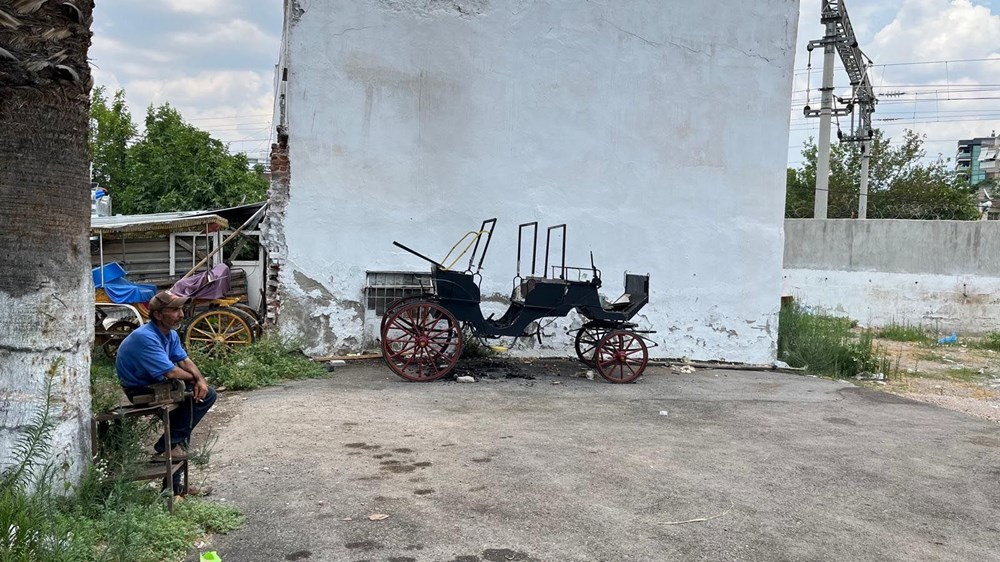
top-left (785, 130), bottom-right (979, 220)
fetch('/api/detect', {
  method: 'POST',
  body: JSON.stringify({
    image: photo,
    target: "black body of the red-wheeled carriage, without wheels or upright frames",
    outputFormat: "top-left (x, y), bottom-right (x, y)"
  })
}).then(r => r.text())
top-left (431, 265), bottom-right (649, 337)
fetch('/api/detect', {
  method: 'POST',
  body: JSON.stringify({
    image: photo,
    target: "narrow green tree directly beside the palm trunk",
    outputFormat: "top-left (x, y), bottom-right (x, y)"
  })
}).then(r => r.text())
top-left (87, 86), bottom-right (136, 191)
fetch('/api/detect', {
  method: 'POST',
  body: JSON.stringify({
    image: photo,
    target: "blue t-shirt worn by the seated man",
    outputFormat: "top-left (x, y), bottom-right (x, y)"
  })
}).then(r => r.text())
top-left (115, 322), bottom-right (187, 387)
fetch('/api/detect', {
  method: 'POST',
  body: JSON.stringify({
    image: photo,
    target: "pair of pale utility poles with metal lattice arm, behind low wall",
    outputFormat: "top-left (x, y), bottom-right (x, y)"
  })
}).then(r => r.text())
top-left (803, 0), bottom-right (878, 219)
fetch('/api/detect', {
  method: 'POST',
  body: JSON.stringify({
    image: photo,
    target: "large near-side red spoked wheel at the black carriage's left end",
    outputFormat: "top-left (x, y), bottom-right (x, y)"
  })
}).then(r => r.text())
top-left (382, 302), bottom-right (462, 382)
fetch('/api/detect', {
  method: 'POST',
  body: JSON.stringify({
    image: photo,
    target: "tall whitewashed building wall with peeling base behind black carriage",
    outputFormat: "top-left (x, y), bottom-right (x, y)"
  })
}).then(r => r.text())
top-left (278, 0), bottom-right (798, 362)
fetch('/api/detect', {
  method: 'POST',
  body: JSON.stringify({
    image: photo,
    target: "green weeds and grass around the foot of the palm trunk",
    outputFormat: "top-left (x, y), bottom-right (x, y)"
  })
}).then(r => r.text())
top-left (0, 363), bottom-right (243, 562)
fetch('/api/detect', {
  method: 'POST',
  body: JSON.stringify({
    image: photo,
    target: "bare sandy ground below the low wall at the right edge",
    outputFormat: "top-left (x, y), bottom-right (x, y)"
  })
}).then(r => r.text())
top-left (862, 334), bottom-right (1000, 422)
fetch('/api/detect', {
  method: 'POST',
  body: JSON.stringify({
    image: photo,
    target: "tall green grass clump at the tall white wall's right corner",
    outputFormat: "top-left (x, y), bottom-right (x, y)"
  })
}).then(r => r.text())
top-left (778, 304), bottom-right (892, 378)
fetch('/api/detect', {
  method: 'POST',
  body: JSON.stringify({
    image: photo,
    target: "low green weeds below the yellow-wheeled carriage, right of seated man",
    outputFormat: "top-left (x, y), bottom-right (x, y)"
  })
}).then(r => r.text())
top-left (192, 336), bottom-right (330, 390)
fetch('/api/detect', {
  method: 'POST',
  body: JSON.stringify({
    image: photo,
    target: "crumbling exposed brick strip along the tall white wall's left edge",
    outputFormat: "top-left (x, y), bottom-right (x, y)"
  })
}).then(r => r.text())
top-left (261, 127), bottom-right (291, 325)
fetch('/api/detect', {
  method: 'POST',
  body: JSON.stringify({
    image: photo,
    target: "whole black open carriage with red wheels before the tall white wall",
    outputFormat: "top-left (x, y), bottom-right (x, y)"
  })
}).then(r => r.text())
top-left (380, 219), bottom-right (656, 383)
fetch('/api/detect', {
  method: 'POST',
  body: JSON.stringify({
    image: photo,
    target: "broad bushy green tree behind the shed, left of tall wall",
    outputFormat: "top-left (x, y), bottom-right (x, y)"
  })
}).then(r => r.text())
top-left (112, 104), bottom-right (268, 214)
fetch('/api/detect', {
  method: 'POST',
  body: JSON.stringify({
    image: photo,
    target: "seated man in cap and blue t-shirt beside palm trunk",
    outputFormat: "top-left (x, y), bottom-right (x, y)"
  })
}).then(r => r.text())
top-left (115, 291), bottom-right (216, 495)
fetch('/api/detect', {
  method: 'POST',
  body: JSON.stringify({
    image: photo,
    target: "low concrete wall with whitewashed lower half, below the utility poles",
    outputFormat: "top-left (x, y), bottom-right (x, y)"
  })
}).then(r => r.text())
top-left (782, 219), bottom-right (1000, 334)
